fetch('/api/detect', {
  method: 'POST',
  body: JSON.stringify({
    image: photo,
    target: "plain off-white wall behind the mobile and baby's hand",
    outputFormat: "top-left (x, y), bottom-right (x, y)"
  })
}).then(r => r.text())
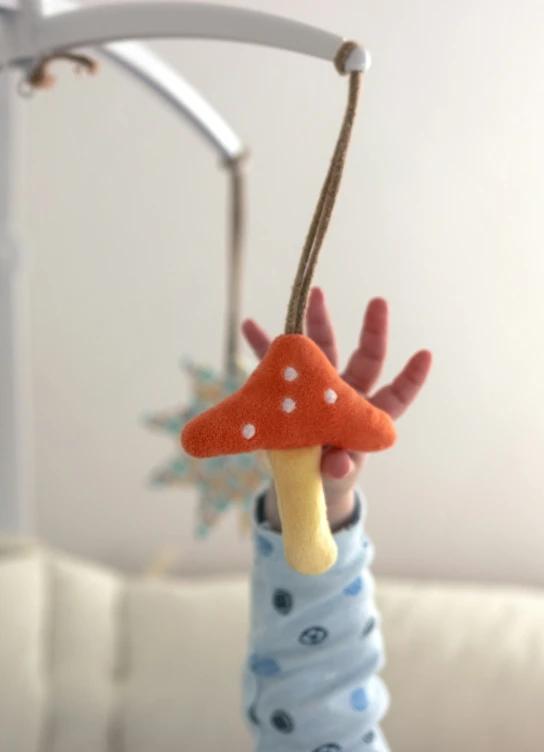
top-left (20, 0), bottom-right (544, 583)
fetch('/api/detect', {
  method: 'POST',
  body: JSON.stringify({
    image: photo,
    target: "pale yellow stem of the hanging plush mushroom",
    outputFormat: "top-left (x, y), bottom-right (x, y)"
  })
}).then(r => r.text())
top-left (268, 446), bottom-right (338, 575)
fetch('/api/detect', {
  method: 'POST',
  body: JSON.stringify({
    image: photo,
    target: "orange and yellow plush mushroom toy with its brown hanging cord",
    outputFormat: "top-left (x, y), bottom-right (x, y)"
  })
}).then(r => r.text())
top-left (181, 42), bottom-right (395, 575)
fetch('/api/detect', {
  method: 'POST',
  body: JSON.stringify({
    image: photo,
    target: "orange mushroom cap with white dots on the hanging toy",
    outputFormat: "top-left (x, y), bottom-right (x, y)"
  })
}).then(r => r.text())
top-left (181, 334), bottom-right (396, 457)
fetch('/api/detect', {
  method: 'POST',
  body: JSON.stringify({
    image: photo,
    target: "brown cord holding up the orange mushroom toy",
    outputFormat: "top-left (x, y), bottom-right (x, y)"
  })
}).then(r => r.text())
top-left (285, 42), bottom-right (362, 334)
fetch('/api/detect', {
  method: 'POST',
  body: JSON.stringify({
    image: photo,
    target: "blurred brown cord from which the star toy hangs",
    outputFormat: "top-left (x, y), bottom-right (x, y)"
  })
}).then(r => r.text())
top-left (225, 153), bottom-right (248, 376)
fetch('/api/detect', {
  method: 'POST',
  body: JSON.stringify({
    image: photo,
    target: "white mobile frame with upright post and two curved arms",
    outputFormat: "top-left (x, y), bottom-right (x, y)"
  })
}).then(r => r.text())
top-left (0, 0), bottom-right (370, 534)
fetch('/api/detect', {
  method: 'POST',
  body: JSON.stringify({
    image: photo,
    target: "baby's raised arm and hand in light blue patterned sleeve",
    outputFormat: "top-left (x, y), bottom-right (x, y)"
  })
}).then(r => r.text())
top-left (240, 290), bottom-right (431, 752)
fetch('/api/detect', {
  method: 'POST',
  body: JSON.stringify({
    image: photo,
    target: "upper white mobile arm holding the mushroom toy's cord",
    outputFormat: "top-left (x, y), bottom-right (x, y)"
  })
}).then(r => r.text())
top-left (0, 0), bottom-right (369, 71)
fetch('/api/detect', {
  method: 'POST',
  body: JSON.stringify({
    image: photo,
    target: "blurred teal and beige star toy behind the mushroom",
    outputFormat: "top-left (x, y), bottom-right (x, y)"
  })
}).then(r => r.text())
top-left (145, 361), bottom-right (269, 538)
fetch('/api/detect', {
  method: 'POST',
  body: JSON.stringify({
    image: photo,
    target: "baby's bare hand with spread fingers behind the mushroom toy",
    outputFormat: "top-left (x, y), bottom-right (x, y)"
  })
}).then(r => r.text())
top-left (243, 288), bottom-right (432, 531)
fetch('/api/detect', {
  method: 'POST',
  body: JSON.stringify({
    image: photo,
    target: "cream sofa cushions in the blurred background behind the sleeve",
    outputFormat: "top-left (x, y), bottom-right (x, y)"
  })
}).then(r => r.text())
top-left (0, 545), bottom-right (544, 752)
